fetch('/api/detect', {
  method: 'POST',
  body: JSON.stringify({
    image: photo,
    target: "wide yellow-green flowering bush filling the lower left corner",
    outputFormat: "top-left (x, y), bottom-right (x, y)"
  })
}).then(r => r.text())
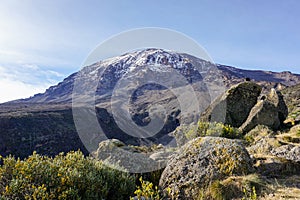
top-left (0, 151), bottom-right (135, 200)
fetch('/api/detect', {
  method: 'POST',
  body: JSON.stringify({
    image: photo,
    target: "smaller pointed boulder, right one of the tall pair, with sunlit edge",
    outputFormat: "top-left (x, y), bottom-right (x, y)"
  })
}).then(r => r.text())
top-left (240, 89), bottom-right (288, 132)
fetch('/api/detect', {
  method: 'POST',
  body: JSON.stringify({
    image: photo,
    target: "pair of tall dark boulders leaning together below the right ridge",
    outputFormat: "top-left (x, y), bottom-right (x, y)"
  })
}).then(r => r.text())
top-left (200, 81), bottom-right (288, 133)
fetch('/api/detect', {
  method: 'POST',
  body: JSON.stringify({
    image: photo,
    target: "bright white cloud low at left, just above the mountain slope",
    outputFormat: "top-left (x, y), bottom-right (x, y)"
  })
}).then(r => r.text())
top-left (0, 65), bottom-right (64, 103)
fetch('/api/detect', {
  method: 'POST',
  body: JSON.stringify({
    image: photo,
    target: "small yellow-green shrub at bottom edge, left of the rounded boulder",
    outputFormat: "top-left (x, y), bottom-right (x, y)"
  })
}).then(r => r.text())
top-left (130, 177), bottom-right (161, 200)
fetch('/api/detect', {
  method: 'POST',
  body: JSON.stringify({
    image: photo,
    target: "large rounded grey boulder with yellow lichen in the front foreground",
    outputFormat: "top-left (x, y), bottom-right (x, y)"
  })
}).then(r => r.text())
top-left (159, 137), bottom-right (252, 199)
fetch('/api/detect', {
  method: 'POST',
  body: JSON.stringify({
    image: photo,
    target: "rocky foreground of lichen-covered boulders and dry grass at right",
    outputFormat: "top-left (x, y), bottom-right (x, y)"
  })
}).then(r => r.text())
top-left (95, 82), bottom-right (300, 199)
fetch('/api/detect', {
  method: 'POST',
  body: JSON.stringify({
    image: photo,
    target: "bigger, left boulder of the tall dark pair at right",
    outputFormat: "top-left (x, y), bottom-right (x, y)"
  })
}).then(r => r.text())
top-left (201, 82), bottom-right (262, 127)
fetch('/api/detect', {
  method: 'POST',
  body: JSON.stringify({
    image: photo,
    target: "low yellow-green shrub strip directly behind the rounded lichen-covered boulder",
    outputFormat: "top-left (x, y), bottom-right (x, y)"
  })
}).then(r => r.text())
top-left (185, 121), bottom-right (241, 140)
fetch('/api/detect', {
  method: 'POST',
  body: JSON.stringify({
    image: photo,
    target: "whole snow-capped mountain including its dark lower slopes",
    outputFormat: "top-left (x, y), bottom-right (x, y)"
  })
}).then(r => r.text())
top-left (0, 49), bottom-right (300, 157)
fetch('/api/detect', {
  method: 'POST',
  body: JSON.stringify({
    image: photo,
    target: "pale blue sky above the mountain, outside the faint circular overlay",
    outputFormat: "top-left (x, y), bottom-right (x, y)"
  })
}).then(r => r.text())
top-left (0, 0), bottom-right (300, 102)
